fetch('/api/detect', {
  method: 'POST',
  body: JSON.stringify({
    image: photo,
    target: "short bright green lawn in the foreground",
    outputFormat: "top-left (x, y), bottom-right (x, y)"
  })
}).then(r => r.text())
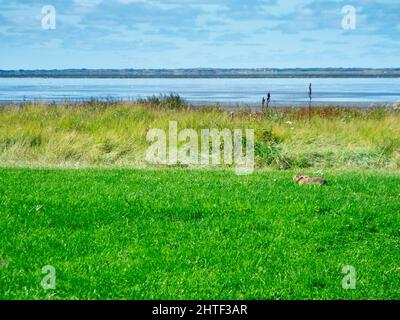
top-left (0, 169), bottom-right (400, 299)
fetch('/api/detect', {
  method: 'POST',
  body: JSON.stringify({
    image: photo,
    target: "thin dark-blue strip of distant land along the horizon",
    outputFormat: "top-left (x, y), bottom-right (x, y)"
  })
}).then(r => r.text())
top-left (0, 68), bottom-right (400, 78)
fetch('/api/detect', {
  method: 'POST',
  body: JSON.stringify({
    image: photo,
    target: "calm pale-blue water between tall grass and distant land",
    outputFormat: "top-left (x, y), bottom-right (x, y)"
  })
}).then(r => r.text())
top-left (0, 78), bottom-right (400, 105)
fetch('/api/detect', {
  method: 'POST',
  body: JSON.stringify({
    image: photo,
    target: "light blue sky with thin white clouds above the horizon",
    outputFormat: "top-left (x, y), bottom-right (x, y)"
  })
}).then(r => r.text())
top-left (0, 0), bottom-right (400, 69)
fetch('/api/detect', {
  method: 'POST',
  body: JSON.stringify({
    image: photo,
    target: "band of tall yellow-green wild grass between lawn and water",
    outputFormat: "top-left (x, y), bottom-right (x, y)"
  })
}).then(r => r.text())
top-left (0, 97), bottom-right (400, 170)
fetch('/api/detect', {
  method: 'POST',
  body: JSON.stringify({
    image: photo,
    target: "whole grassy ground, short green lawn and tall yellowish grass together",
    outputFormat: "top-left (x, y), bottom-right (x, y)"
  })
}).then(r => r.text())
top-left (0, 97), bottom-right (400, 299)
